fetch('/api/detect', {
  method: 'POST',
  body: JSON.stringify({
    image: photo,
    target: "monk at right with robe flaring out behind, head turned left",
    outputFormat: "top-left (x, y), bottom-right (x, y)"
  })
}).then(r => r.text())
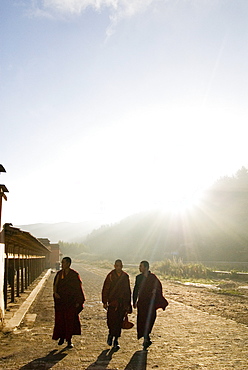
top-left (133, 261), bottom-right (168, 350)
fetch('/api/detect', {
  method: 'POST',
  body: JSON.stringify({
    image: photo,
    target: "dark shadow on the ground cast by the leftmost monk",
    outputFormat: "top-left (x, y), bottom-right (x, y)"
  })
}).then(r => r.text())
top-left (19, 348), bottom-right (67, 370)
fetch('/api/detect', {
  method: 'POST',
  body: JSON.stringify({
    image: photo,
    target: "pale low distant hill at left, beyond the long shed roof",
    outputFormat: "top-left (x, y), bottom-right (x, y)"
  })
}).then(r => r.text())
top-left (17, 221), bottom-right (101, 243)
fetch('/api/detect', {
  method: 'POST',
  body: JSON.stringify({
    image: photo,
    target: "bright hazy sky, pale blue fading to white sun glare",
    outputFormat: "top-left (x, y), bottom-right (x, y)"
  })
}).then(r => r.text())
top-left (0, 0), bottom-right (248, 225)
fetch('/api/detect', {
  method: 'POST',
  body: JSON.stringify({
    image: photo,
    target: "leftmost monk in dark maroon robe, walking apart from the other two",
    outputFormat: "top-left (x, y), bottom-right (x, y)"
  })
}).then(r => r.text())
top-left (52, 257), bottom-right (85, 348)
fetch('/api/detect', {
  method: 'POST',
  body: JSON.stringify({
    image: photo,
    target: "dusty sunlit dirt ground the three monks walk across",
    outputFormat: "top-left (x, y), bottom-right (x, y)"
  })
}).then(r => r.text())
top-left (0, 264), bottom-right (248, 370)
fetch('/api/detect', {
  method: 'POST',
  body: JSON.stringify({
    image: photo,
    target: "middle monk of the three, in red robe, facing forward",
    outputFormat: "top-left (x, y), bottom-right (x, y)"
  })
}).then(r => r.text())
top-left (102, 259), bottom-right (132, 349)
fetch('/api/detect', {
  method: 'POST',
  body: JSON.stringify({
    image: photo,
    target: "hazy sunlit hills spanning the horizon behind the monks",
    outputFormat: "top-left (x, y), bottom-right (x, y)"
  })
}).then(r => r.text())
top-left (16, 167), bottom-right (248, 262)
